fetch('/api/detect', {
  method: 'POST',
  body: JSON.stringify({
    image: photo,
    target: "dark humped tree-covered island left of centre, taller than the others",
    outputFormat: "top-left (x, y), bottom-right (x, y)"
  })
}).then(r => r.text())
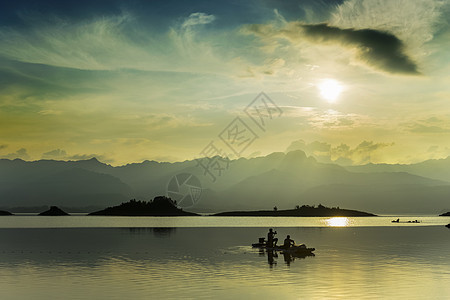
top-left (89, 196), bottom-right (198, 217)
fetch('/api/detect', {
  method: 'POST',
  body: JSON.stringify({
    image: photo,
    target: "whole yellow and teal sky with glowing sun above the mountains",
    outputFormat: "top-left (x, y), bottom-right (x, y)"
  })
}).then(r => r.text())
top-left (0, 0), bottom-right (450, 165)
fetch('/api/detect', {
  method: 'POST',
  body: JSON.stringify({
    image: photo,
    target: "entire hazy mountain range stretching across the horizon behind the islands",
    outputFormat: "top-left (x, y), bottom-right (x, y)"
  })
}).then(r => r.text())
top-left (0, 150), bottom-right (450, 214)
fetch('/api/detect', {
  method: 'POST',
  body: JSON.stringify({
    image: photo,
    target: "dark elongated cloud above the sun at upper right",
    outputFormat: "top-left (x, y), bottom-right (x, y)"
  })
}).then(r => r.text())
top-left (298, 24), bottom-right (420, 75)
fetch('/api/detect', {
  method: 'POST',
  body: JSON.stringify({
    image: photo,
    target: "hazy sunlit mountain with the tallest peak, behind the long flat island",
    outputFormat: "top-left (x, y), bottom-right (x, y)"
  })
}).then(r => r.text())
top-left (193, 151), bottom-right (450, 213)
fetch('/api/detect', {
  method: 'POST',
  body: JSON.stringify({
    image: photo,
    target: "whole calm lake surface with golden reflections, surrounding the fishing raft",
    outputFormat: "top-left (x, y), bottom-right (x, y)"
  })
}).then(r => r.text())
top-left (0, 216), bottom-right (450, 299)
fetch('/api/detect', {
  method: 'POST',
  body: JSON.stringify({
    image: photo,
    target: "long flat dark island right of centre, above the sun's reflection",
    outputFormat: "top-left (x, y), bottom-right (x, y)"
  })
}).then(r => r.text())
top-left (213, 204), bottom-right (376, 217)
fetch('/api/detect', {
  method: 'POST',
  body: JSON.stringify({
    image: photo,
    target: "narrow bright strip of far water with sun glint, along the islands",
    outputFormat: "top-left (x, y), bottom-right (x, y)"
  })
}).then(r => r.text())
top-left (0, 214), bottom-right (450, 228)
